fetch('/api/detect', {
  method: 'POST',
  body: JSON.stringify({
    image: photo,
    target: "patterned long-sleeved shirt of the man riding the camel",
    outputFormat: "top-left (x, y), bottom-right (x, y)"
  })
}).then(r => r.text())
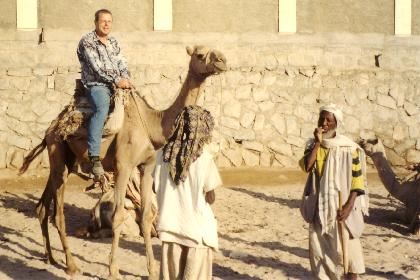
top-left (77, 30), bottom-right (129, 87)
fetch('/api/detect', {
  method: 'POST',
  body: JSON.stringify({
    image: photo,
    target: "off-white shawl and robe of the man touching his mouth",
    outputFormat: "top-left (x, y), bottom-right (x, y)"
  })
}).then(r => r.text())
top-left (309, 135), bottom-right (368, 280)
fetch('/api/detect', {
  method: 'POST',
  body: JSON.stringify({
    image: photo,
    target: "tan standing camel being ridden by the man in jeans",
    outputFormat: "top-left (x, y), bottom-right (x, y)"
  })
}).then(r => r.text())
top-left (20, 46), bottom-right (227, 279)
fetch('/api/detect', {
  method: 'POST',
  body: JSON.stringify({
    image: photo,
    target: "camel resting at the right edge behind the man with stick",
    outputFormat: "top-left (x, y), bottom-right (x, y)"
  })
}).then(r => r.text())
top-left (360, 139), bottom-right (420, 235)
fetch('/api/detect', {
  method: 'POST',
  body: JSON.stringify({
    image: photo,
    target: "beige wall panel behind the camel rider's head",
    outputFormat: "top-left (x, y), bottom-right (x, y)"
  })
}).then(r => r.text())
top-left (38, 0), bottom-right (153, 31)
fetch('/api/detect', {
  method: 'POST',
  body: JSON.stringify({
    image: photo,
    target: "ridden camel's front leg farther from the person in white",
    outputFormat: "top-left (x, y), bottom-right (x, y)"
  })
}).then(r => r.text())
top-left (109, 163), bottom-right (133, 279)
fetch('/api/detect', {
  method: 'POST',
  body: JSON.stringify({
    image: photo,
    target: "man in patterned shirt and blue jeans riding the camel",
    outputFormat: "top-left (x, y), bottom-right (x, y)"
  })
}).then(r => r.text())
top-left (77, 9), bottom-right (132, 179)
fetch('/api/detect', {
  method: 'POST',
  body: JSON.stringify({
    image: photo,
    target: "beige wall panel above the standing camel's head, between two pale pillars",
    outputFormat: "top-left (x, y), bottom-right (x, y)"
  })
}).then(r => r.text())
top-left (172, 0), bottom-right (278, 32)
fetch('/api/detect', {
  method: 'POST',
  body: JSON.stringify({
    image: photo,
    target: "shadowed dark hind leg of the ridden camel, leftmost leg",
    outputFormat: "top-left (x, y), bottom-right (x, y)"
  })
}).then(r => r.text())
top-left (36, 179), bottom-right (57, 265)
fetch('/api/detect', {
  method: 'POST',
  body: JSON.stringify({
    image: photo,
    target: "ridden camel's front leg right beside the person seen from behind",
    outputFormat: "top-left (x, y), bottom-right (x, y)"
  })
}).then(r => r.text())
top-left (140, 154), bottom-right (158, 279)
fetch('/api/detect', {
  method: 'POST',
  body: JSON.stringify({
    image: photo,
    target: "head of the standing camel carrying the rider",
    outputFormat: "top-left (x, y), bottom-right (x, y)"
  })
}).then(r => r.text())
top-left (187, 46), bottom-right (227, 78)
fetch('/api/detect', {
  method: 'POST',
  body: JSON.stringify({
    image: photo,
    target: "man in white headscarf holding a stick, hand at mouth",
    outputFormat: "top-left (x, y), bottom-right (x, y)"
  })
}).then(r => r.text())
top-left (301, 104), bottom-right (367, 279)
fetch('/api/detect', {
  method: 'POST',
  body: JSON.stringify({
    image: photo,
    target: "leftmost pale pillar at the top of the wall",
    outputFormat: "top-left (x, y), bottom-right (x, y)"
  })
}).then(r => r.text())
top-left (16, 0), bottom-right (38, 29)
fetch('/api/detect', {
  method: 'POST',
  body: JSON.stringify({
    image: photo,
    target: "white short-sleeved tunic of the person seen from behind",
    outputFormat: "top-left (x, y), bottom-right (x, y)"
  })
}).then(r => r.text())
top-left (154, 148), bottom-right (222, 250)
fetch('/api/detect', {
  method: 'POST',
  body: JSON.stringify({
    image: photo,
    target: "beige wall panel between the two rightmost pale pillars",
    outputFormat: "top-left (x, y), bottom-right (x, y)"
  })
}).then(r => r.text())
top-left (296, 0), bottom-right (394, 34)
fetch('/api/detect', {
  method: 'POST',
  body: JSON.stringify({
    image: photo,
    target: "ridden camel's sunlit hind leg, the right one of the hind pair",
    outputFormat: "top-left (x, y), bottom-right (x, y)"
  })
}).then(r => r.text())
top-left (55, 176), bottom-right (78, 275)
